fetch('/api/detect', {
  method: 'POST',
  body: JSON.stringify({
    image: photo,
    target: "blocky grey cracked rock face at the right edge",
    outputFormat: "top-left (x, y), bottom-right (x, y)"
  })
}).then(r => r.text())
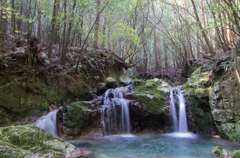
top-left (209, 72), bottom-right (240, 141)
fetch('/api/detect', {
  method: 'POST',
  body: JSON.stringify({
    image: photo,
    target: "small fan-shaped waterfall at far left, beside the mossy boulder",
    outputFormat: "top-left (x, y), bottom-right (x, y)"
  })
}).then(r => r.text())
top-left (34, 109), bottom-right (59, 137)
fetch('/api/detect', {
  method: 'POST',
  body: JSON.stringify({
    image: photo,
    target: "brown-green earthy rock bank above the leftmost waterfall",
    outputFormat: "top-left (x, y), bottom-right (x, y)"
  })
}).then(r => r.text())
top-left (0, 52), bottom-right (124, 127)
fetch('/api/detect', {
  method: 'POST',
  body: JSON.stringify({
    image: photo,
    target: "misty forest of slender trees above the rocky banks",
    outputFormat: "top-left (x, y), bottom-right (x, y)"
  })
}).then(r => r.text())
top-left (0, 0), bottom-right (240, 78)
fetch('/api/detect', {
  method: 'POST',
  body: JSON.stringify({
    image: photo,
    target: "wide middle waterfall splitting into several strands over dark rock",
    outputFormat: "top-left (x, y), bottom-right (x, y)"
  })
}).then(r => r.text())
top-left (99, 88), bottom-right (130, 134)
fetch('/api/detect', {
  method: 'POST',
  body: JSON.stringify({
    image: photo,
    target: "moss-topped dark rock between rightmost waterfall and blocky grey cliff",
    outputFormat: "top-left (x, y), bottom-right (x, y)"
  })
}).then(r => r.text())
top-left (183, 67), bottom-right (217, 134)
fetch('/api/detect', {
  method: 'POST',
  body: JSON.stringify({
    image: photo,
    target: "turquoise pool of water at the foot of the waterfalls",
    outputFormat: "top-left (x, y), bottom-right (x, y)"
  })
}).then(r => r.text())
top-left (69, 133), bottom-right (240, 158)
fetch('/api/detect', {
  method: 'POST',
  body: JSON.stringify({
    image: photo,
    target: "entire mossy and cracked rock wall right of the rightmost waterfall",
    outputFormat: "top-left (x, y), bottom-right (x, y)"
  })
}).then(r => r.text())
top-left (183, 57), bottom-right (240, 142)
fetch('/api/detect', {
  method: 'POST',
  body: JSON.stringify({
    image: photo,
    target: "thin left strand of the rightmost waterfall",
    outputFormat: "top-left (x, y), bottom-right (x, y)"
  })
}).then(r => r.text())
top-left (170, 89), bottom-right (178, 131)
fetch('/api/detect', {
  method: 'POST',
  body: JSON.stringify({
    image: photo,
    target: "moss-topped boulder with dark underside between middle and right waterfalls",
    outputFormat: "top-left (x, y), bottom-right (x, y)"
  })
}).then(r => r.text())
top-left (130, 78), bottom-right (171, 133)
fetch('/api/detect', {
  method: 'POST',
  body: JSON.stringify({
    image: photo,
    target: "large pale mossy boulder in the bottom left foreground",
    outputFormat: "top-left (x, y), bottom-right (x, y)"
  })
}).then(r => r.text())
top-left (0, 124), bottom-right (94, 158)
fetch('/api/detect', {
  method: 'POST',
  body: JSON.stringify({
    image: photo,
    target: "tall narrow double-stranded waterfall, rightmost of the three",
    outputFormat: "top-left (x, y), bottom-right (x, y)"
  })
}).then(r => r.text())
top-left (170, 88), bottom-right (188, 133)
